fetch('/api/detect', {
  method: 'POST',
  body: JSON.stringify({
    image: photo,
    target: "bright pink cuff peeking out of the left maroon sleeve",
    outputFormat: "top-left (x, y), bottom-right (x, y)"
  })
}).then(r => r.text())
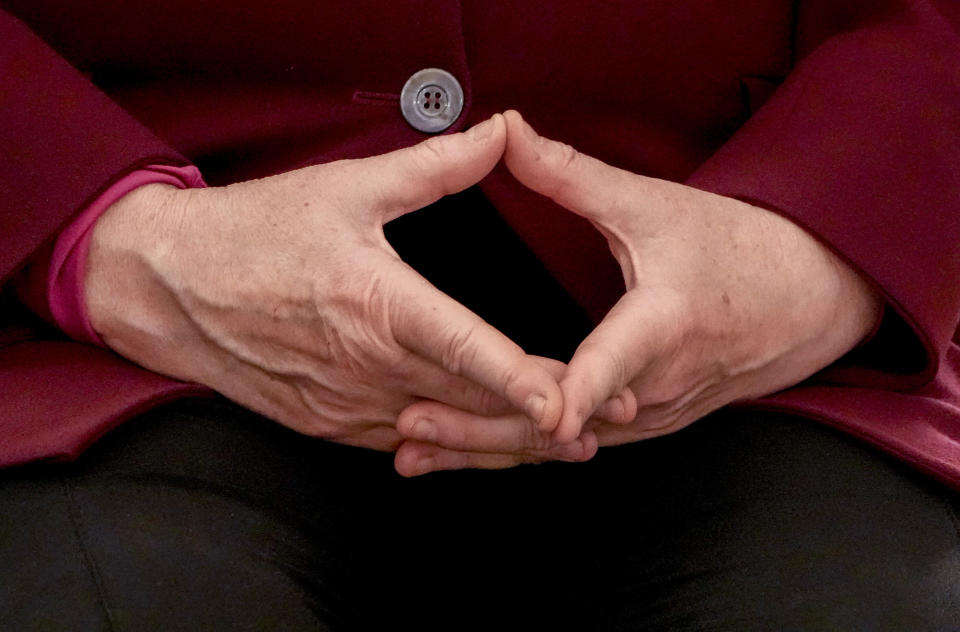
top-left (47, 165), bottom-right (207, 347)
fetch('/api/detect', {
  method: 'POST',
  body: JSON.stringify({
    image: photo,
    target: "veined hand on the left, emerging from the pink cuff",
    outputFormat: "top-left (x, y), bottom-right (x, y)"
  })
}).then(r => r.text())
top-left (86, 115), bottom-right (562, 450)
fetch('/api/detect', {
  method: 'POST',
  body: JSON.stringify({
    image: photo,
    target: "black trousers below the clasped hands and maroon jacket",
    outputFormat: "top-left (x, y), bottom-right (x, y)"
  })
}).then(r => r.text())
top-left (0, 190), bottom-right (960, 631)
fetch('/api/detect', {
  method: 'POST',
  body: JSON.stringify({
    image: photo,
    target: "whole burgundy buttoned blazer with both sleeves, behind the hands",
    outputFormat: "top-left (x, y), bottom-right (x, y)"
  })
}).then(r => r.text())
top-left (0, 0), bottom-right (960, 487)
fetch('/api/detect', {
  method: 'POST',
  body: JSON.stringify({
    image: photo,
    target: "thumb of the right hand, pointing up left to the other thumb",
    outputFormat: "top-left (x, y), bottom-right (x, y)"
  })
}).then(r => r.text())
top-left (504, 110), bottom-right (636, 230)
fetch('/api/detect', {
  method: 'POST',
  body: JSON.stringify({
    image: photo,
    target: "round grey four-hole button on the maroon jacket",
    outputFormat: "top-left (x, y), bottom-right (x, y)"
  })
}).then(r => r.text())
top-left (400, 68), bottom-right (463, 134)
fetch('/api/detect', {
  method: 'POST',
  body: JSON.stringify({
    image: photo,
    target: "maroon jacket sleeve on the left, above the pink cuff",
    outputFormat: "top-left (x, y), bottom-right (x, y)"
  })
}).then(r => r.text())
top-left (0, 10), bottom-right (187, 285)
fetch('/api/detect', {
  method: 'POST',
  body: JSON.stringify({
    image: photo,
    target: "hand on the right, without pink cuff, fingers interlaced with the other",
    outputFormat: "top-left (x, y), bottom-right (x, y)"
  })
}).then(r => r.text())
top-left (397, 112), bottom-right (882, 474)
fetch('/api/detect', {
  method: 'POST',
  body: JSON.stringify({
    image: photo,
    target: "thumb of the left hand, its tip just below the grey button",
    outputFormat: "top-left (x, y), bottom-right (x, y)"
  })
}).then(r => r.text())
top-left (353, 114), bottom-right (506, 223)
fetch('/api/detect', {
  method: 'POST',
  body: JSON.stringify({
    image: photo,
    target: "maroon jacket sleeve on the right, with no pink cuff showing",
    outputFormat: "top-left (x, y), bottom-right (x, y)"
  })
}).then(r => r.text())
top-left (688, 0), bottom-right (960, 388)
